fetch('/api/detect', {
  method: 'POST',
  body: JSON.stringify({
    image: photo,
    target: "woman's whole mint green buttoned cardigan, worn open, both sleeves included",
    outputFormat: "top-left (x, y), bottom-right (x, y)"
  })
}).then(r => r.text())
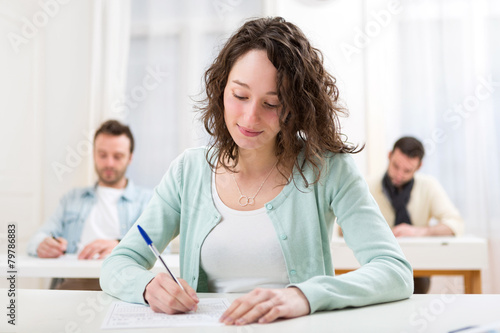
top-left (100, 148), bottom-right (413, 313)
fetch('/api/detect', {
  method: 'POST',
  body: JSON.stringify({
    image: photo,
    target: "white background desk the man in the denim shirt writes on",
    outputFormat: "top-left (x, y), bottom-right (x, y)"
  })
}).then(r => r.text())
top-left (0, 254), bottom-right (180, 278)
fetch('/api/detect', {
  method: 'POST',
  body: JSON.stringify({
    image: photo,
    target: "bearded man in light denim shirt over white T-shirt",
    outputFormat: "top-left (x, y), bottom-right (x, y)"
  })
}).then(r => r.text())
top-left (28, 120), bottom-right (152, 288)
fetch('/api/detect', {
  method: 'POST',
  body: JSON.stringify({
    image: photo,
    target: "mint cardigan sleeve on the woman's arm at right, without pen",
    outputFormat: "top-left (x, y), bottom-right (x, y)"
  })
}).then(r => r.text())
top-left (291, 155), bottom-right (413, 313)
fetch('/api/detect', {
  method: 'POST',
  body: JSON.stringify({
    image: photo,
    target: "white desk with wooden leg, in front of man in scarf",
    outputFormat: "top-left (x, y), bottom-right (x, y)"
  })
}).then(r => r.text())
top-left (331, 236), bottom-right (488, 292)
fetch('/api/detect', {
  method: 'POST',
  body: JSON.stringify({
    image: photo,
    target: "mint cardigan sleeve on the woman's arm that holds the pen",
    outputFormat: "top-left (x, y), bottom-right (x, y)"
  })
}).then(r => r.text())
top-left (100, 155), bottom-right (183, 303)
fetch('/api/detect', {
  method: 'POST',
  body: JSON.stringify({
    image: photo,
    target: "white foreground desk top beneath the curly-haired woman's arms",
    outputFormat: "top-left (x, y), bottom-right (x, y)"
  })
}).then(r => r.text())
top-left (0, 289), bottom-right (500, 333)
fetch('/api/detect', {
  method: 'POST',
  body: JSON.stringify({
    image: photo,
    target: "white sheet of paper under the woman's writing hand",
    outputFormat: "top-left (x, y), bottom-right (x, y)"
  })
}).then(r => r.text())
top-left (101, 298), bottom-right (229, 329)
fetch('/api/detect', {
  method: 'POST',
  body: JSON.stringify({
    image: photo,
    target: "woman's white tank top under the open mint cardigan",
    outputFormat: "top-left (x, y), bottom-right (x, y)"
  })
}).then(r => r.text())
top-left (201, 175), bottom-right (290, 293)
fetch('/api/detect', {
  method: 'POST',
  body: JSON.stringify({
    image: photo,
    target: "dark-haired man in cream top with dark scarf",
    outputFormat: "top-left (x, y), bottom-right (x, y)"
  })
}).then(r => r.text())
top-left (369, 137), bottom-right (464, 293)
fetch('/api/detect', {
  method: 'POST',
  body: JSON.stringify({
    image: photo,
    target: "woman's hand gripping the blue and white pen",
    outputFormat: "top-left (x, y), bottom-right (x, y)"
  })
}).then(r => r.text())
top-left (144, 273), bottom-right (200, 314)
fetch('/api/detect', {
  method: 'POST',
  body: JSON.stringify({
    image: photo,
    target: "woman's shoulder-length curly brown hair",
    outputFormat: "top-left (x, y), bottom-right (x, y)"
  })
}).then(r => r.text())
top-left (199, 17), bottom-right (363, 187)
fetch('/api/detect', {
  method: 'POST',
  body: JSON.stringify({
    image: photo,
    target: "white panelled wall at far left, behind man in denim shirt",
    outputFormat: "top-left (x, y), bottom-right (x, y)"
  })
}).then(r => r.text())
top-left (0, 0), bottom-right (91, 286)
